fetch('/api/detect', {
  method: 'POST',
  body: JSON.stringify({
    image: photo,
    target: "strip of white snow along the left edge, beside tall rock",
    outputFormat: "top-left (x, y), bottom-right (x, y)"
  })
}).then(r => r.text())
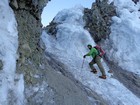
top-left (0, 0), bottom-right (24, 105)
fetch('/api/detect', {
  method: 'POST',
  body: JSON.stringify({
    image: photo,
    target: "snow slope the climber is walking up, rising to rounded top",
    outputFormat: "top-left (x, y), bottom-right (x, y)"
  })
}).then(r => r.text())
top-left (41, 7), bottom-right (140, 105)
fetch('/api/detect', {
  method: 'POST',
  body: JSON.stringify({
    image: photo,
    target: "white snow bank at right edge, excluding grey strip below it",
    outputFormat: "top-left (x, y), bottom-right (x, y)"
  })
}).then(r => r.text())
top-left (105, 0), bottom-right (140, 75)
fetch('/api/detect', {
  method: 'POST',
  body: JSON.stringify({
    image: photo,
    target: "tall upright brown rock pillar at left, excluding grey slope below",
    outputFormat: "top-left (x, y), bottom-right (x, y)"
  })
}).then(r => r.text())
top-left (10, 0), bottom-right (48, 84)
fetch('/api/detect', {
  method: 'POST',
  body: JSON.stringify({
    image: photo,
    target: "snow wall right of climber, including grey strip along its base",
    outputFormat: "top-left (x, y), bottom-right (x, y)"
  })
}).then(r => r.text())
top-left (103, 0), bottom-right (140, 97)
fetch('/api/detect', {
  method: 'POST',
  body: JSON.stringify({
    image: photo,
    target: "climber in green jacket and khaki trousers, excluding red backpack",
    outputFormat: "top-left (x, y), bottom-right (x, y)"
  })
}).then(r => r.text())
top-left (83, 44), bottom-right (106, 79)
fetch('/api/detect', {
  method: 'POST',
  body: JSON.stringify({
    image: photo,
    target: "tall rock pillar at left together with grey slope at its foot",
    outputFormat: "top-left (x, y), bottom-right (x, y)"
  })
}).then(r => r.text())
top-left (9, 0), bottom-right (106, 105)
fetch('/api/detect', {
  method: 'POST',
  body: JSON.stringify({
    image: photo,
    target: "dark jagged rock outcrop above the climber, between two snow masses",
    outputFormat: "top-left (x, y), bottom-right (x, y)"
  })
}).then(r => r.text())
top-left (83, 0), bottom-right (116, 42)
